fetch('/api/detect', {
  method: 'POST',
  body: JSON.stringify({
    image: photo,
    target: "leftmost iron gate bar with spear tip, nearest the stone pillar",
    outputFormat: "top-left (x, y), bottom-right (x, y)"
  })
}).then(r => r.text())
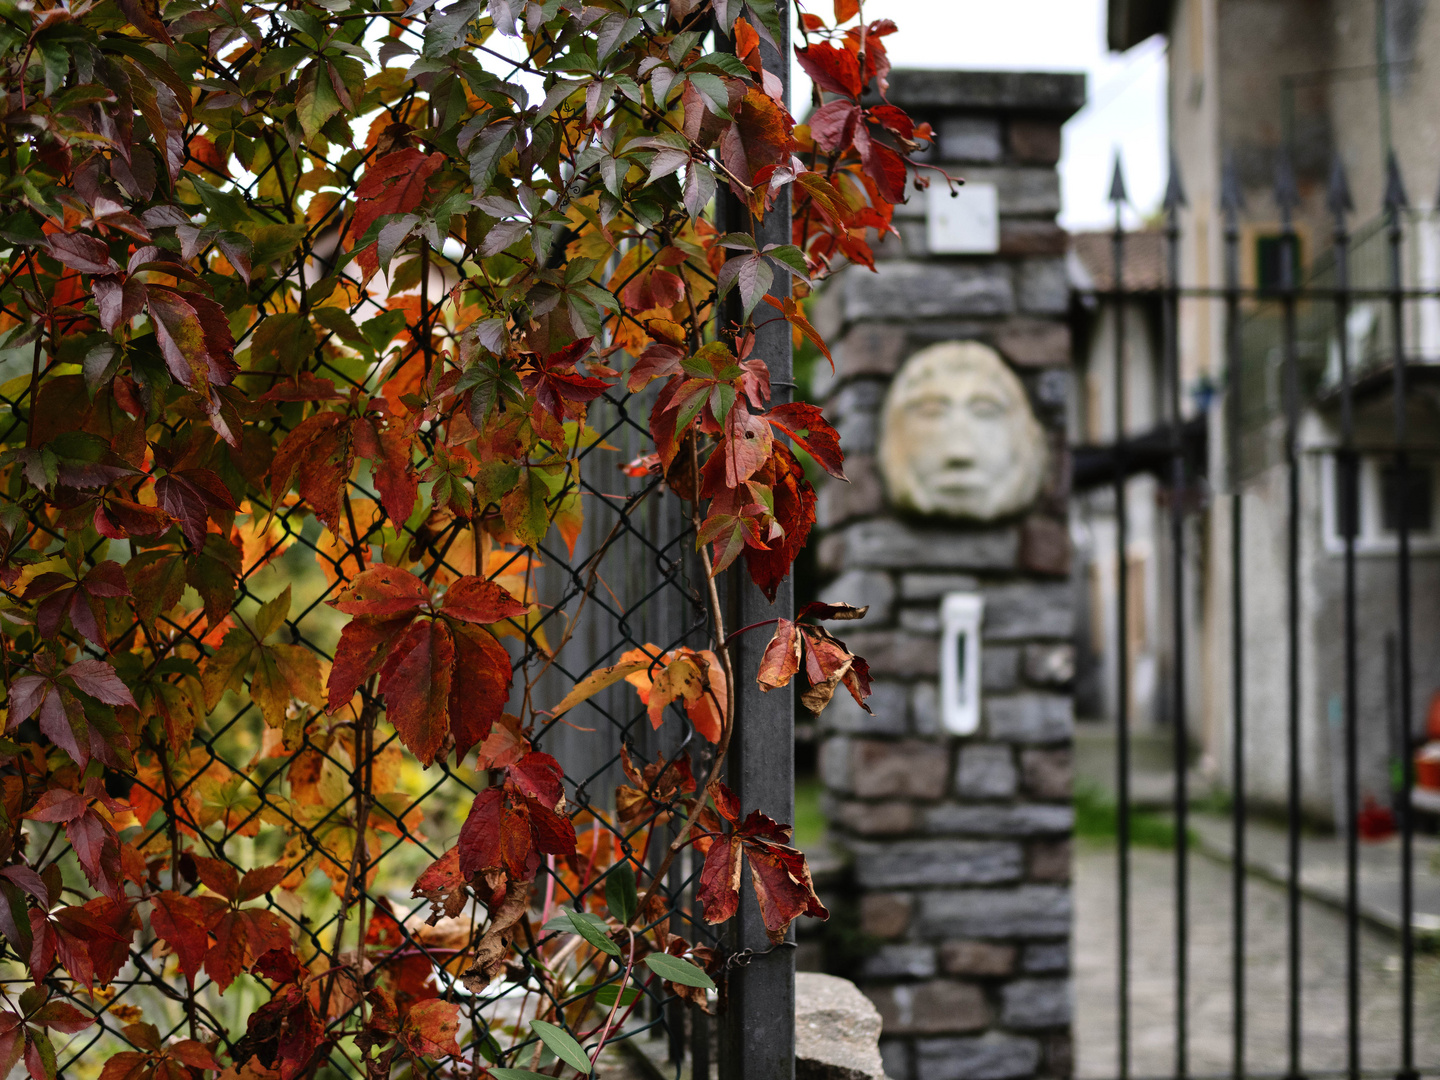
top-left (1110, 156), bottom-right (1130, 1080)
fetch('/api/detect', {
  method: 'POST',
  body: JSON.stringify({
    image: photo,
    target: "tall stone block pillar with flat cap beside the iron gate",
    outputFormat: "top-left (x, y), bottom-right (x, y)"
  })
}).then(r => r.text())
top-left (816, 71), bottom-right (1084, 1080)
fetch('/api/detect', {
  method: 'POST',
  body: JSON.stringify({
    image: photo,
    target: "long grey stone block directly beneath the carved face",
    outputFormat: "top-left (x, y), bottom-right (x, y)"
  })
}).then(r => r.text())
top-left (827, 518), bottom-right (1020, 570)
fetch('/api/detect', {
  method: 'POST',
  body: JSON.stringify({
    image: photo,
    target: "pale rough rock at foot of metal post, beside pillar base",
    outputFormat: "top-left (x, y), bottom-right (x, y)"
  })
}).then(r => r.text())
top-left (795, 972), bottom-right (886, 1080)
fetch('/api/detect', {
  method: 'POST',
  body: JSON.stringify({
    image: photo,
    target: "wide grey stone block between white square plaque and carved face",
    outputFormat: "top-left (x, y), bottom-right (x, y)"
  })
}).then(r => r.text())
top-left (832, 259), bottom-right (1015, 323)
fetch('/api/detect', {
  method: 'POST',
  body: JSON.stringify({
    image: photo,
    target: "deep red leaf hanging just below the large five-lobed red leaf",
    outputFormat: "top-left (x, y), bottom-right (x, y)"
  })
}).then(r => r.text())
top-left (459, 780), bottom-right (575, 881)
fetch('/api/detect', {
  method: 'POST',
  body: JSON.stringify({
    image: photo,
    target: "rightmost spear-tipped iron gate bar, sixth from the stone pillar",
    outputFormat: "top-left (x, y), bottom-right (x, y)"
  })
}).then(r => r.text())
top-left (1385, 150), bottom-right (1416, 1080)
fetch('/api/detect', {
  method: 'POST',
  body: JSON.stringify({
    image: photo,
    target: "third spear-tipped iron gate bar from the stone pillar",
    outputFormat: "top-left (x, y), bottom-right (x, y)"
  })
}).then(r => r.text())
top-left (1220, 158), bottom-right (1246, 1080)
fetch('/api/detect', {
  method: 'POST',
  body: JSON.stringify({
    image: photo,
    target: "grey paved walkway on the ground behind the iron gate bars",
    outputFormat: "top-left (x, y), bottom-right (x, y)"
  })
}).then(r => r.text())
top-left (1074, 841), bottom-right (1440, 1077)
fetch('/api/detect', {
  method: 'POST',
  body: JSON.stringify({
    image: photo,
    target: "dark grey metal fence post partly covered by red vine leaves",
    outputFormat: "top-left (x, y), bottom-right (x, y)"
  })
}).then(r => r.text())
top-left (719, 0), bottom-right (795, 1080)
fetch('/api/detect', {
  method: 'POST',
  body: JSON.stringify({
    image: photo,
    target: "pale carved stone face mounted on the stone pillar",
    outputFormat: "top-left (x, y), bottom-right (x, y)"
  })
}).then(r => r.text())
top-left (880, 341), bottom-right (1045, 521)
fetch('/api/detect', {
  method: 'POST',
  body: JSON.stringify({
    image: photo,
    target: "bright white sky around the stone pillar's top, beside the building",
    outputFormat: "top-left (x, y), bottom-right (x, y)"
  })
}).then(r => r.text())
top-left (791, 0), bottom-right (1166, 229)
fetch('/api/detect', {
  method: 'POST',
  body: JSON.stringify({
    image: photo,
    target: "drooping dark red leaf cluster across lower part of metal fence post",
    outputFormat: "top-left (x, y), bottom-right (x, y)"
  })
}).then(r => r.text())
top-left (697, 782), bottom-right (829, 943)
